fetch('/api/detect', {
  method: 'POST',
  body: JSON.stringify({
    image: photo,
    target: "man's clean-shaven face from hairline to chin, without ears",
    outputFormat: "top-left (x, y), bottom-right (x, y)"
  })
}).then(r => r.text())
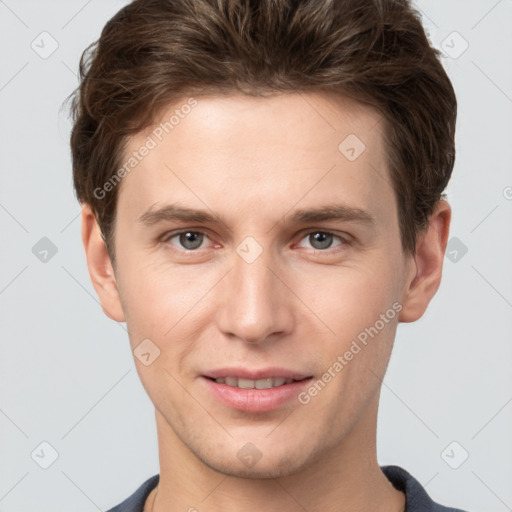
top-left (101, 93), bottom-right (420, 477)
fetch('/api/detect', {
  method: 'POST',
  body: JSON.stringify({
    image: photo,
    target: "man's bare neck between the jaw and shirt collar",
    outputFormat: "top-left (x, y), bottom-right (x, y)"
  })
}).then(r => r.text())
top-left (144, 394), bottom-right (405, 512)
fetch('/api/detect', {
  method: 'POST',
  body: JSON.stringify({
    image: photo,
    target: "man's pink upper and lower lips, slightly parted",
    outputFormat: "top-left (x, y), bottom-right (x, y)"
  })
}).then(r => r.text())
top-left (200, 368), bottom-right (313, 413)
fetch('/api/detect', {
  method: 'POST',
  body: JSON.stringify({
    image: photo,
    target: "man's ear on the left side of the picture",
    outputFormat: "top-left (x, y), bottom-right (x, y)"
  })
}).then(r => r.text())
top-left (82, 204), bottom-right (125, 322)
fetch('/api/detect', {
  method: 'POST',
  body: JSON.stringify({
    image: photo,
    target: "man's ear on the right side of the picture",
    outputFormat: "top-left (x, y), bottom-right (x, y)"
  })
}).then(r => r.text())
top-left (398, 199), bottom-right (451, 322)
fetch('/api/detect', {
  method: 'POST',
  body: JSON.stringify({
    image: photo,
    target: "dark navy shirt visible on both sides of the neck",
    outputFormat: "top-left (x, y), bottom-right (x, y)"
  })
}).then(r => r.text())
top-left (108, 466), bottom-right (470, 512)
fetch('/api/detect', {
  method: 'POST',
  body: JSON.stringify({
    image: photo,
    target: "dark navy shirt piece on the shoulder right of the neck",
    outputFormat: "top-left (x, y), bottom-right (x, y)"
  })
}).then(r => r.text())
top-left (381, 466), bottom-right (465, 512)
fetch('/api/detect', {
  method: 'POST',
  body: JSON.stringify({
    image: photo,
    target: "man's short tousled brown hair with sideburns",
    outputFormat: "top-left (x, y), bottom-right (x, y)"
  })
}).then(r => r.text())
top-left (71, 0), bottom-right (457, 263)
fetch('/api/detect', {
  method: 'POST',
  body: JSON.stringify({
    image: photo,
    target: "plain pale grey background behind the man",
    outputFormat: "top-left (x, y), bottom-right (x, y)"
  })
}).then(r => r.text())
top-left (0, 0), bottom-right (512, 512)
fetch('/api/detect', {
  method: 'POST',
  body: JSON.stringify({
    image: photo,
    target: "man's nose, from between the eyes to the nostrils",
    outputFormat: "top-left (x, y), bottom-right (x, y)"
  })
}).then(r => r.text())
top-left (217, 243), bottom-right (294, 344)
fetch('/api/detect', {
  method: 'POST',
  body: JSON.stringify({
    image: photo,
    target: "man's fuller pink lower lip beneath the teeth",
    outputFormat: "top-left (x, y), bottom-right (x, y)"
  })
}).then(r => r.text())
top-left (201, 377), bottom-right (312, 412)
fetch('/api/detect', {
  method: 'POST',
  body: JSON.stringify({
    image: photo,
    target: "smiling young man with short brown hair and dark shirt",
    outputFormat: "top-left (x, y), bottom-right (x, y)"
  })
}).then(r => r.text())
top-left (71, 0), bottom-right (468, 512)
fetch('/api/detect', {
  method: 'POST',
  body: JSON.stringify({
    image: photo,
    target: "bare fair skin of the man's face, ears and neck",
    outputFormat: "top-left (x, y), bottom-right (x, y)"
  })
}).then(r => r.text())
top-left (82, 93), bottom-right (451, 512)
